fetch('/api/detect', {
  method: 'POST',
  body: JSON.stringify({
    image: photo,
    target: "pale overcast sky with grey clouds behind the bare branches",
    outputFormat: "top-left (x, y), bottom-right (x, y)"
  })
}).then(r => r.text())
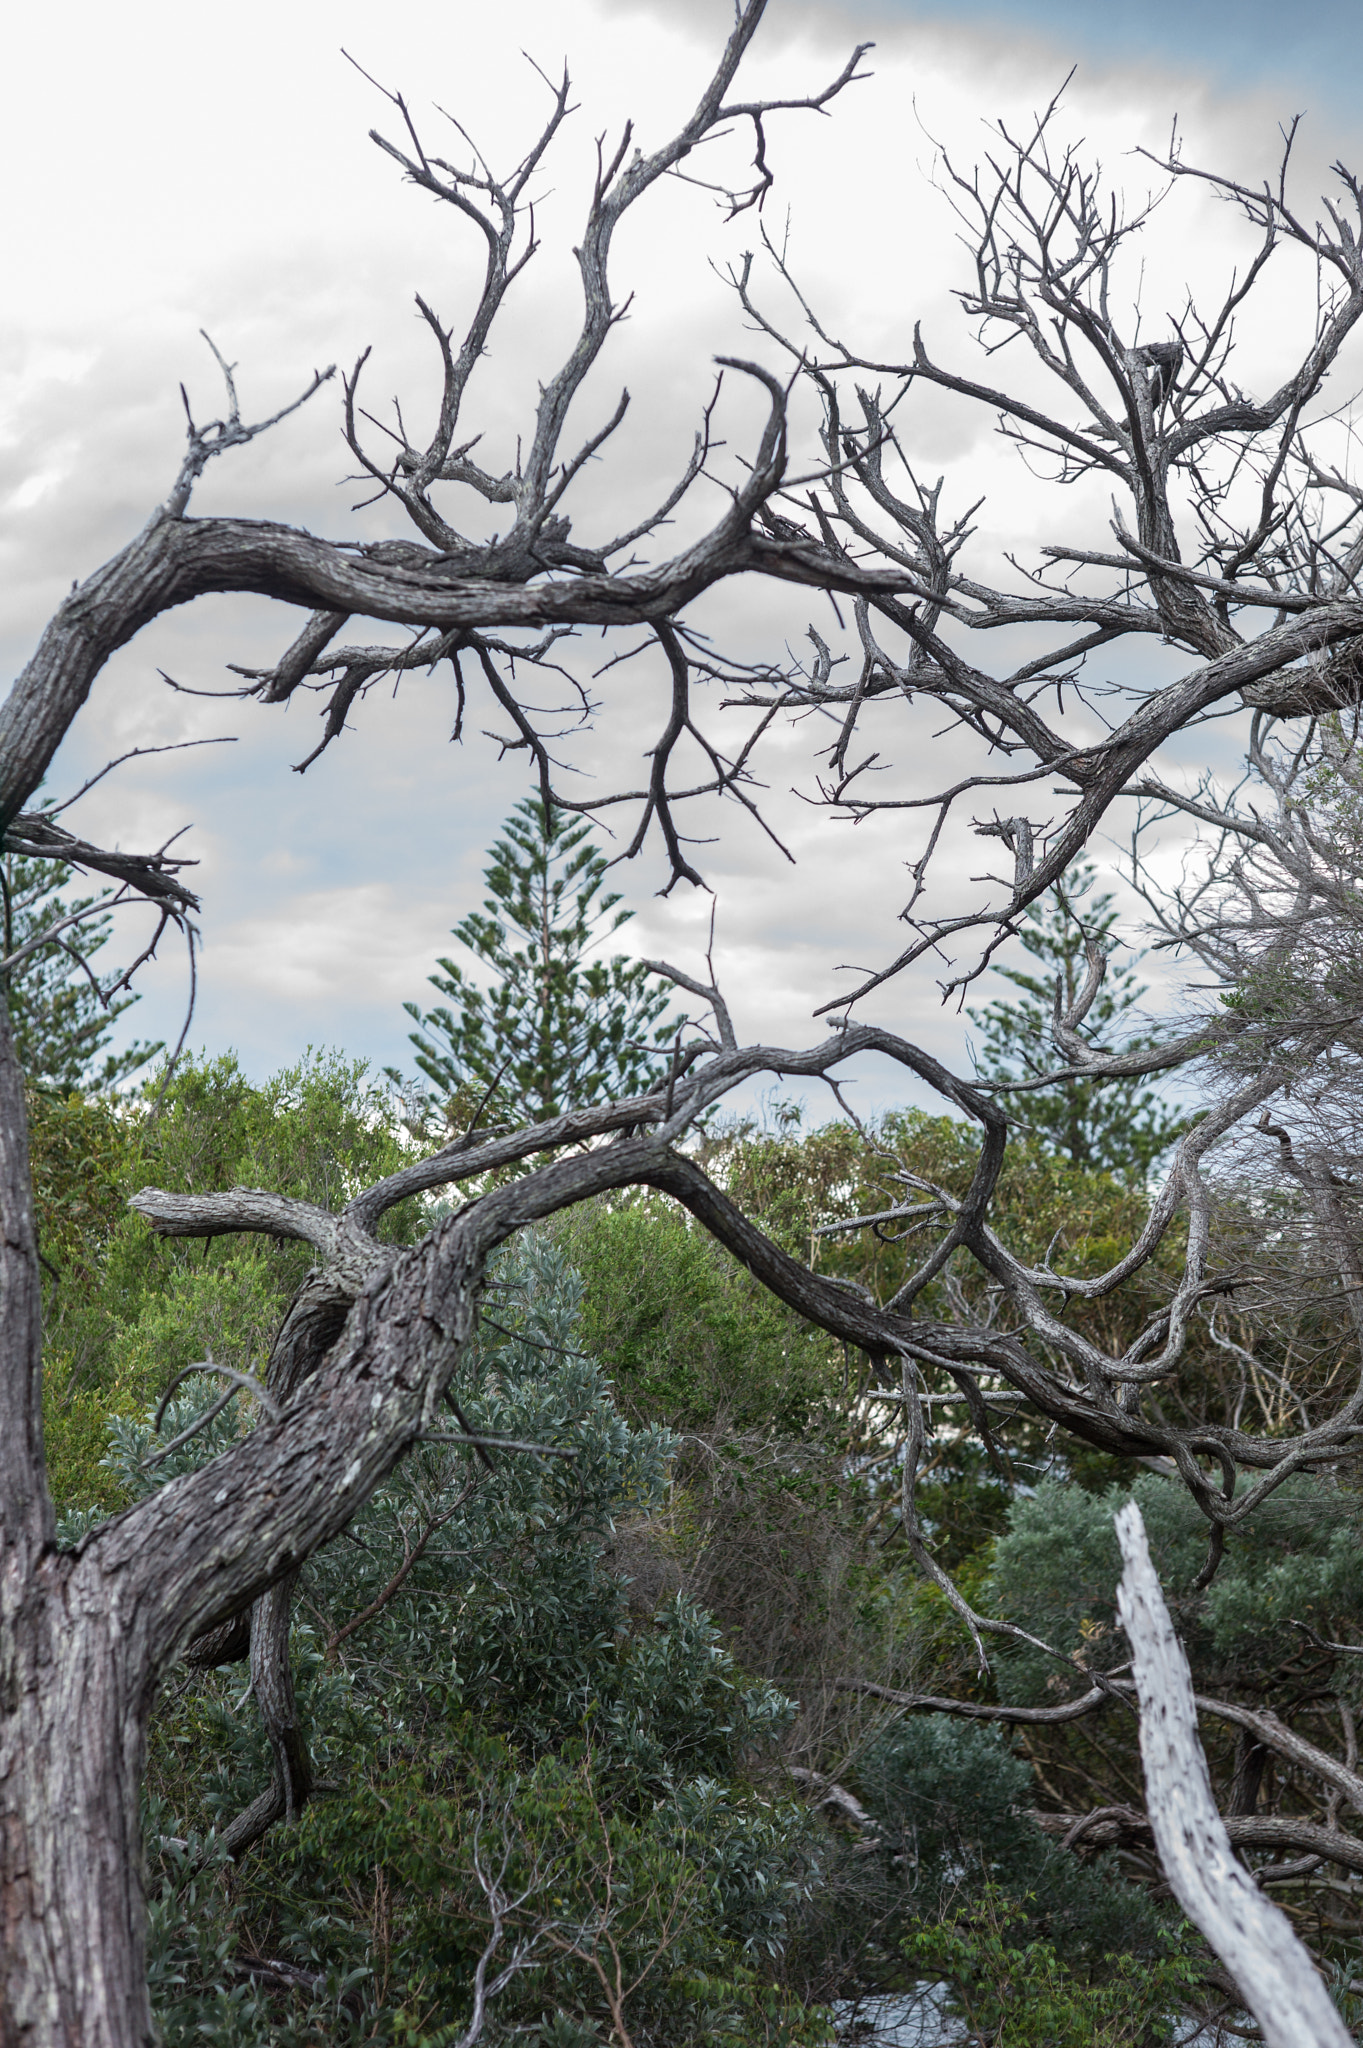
top-left (0, 0), bottom-right (1363, 1100)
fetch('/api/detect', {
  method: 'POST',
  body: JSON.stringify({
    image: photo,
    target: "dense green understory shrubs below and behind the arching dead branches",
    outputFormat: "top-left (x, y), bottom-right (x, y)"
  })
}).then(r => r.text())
top-left (31, 1032), bottom-right (1363, 2048)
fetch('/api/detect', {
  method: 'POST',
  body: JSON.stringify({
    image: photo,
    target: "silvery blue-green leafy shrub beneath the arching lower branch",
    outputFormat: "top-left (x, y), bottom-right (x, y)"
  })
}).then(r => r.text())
top-left (303, 1233), bottom-right (792, 1778)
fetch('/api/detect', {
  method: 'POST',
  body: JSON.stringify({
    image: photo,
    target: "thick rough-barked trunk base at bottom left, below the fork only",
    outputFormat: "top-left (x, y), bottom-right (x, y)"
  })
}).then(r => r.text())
top-left (0, 1552), bottom-right (153, 2048)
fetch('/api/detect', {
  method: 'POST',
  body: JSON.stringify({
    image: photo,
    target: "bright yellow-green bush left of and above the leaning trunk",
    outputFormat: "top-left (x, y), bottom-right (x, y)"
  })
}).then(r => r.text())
top-left (31, 1053), bottom-right (422, 1507)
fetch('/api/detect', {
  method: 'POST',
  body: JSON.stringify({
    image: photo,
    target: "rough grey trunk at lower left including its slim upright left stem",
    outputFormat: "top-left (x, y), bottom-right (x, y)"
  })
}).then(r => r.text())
top-left (0, 987), bottom-right (151, 2048)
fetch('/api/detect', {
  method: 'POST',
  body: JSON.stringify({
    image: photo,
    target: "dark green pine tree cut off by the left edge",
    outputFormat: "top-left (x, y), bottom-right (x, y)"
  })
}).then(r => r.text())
top-left (0, 854), bottom-right (162, 1096)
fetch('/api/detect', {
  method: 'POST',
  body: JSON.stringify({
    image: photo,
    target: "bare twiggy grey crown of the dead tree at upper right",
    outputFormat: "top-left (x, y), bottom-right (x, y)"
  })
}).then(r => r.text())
top-left (735, 100), bottom-right (1363, 1010)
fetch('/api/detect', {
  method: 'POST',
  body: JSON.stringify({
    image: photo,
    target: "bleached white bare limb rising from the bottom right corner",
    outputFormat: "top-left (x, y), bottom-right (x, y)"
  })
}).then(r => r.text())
top-left (1117, 1501), bottom-right (1353, 2048)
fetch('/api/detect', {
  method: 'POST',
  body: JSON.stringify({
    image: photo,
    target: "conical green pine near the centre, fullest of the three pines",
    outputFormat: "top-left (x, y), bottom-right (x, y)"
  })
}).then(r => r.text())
top-left (393, 797), bottom-right (675, 1122)
